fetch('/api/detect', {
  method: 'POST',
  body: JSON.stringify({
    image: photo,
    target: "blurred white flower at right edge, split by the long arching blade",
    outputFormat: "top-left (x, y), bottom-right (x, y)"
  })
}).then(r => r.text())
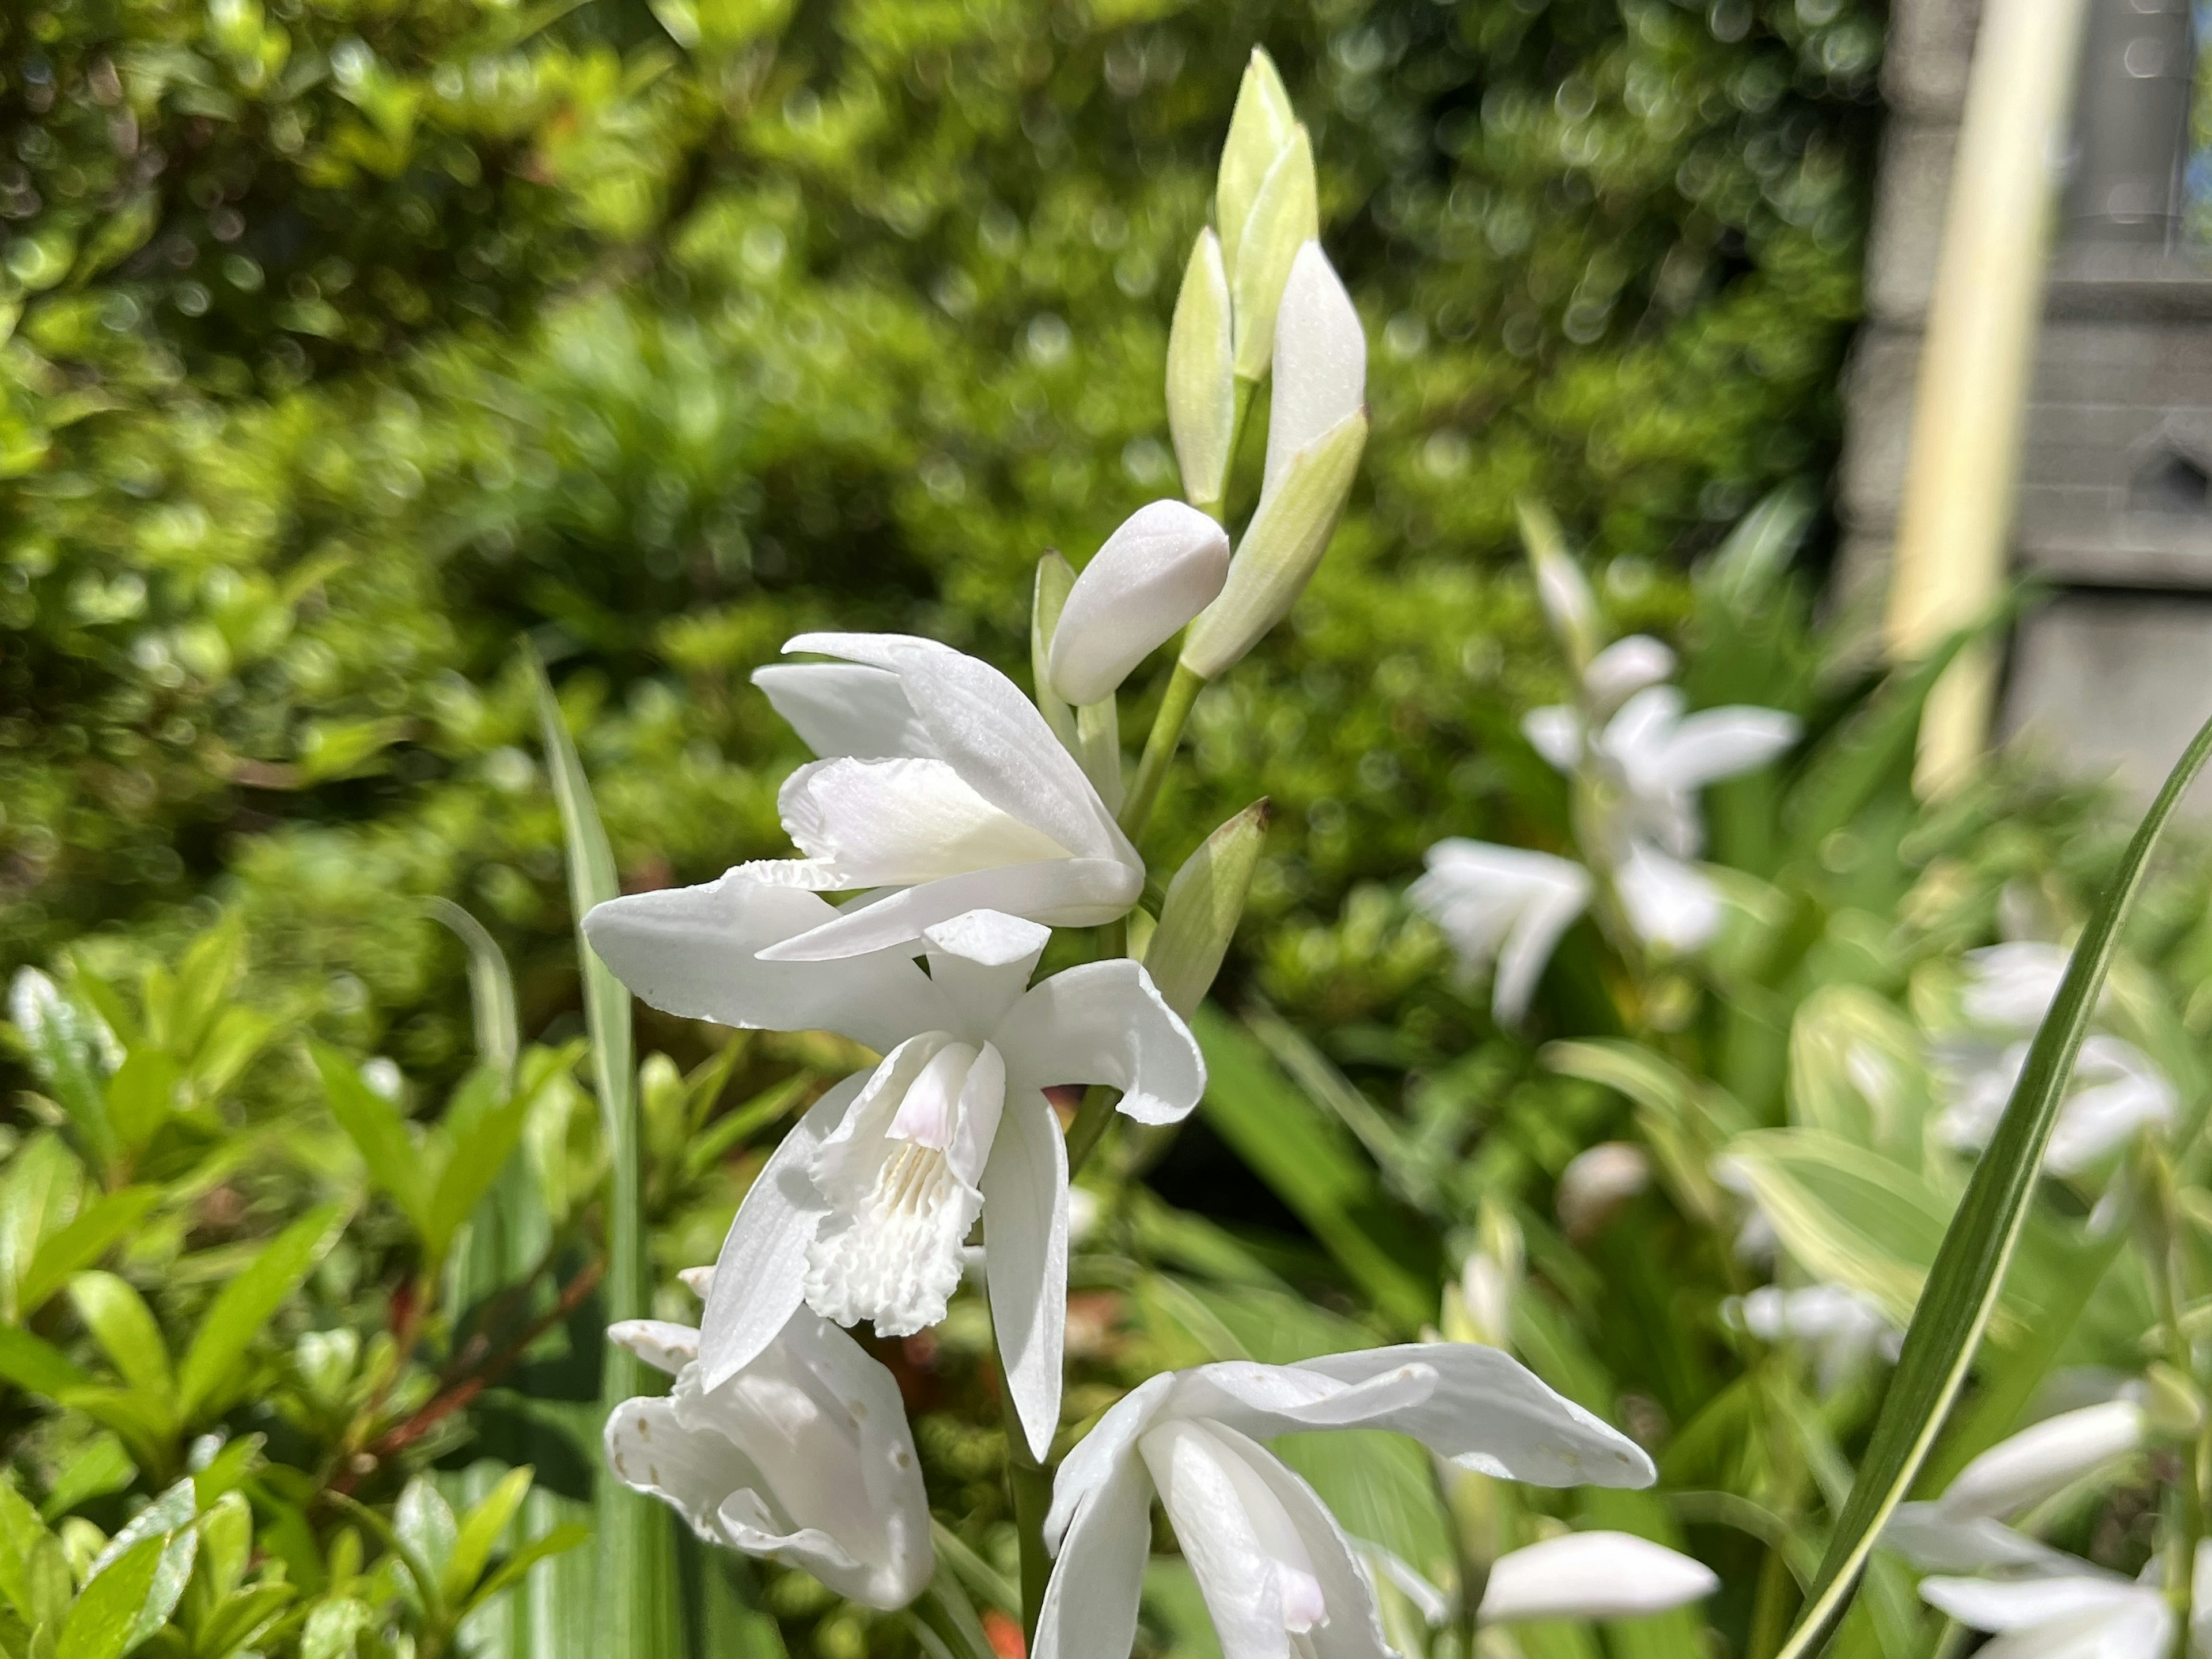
top-left (1931, 942), bottom-right (2181, 1177)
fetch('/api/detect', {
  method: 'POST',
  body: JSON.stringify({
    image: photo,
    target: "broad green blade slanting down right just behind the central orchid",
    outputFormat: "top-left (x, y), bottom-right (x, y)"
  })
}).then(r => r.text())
top-left (1190, 1006), bottom-right (1435, 1332)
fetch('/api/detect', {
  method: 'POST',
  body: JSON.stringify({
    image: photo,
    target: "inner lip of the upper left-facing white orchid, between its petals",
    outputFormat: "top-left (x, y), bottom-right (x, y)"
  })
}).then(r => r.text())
top-left (760, 759), bottom-right (1069, 889)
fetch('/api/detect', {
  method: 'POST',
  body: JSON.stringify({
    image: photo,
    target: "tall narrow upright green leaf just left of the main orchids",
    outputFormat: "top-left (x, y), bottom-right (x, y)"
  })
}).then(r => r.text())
top-left (529, 657), bottom-right (679, 1659)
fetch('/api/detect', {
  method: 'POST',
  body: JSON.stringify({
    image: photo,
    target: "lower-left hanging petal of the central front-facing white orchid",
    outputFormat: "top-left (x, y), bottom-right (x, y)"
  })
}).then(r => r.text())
top-left (699, 1073), bottom-right (854, 1389)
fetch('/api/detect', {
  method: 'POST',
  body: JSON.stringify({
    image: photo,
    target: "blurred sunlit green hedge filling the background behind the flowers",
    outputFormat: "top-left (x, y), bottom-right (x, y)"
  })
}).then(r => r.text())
top-left (0, 0), bottom-right (1880, 1075)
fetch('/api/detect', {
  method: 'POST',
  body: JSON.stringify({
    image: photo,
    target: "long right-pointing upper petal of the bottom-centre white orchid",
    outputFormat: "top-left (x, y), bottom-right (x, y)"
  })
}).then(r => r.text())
top-left (1290, 1343), bottom-right (1657, 1486)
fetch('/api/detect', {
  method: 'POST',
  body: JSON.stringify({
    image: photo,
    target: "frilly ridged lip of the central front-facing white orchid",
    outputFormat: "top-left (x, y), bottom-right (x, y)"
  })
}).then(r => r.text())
top-left (805, 1033), bottom-right (1006, 1336)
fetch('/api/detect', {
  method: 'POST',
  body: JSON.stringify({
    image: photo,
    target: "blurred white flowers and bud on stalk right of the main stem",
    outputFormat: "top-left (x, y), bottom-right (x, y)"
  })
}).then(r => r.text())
top-left (1407, 527), bottom-right (1798, 1024)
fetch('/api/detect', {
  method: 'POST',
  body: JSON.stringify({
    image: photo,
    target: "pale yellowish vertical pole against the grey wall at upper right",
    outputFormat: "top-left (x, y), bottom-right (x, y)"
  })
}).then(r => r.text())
top-left (1887, 0), bottom-right (2086, 794)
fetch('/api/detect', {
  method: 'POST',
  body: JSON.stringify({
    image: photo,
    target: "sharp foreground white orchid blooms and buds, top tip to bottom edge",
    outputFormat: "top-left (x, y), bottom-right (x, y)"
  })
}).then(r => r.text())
top-left (584, 45), bottom-right (1712, 1659)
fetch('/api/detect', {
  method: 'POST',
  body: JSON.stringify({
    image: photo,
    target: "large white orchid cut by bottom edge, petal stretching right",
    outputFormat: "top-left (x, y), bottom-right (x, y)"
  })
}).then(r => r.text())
top-left (1033, 1343), bottom-right (1654, 1659)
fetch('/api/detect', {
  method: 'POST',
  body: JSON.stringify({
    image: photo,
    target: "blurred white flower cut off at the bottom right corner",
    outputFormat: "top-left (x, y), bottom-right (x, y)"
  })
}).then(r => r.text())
top-left (1920, 1544), bottom-right (2212, 1659)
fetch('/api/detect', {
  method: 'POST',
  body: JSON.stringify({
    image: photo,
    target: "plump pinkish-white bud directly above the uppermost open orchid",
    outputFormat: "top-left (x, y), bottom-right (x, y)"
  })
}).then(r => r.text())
top-left (1048, 502), bottom-right (1230, 708)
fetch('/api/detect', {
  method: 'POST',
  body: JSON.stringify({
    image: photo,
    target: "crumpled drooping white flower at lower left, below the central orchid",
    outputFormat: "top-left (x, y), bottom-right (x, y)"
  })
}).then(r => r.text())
top-left (606, 1309), bottom-right (935, 1608)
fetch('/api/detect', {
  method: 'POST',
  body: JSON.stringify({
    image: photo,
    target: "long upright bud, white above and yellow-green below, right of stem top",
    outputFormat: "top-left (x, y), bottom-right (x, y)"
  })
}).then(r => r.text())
top-left (1183, 243), bottom-right (1367, 679)
